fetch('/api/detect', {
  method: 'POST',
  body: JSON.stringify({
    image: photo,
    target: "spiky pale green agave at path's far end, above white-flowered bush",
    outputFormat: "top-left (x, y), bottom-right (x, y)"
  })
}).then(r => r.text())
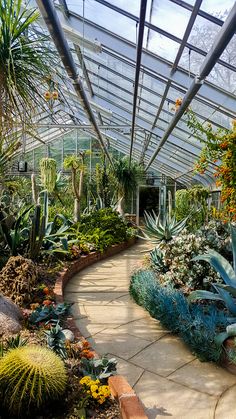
top-left (141, 211), bottom-right (189, 244)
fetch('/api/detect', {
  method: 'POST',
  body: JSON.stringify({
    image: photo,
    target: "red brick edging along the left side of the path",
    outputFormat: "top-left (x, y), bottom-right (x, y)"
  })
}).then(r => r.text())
top-left (54, 238), bottom-right (148, 419)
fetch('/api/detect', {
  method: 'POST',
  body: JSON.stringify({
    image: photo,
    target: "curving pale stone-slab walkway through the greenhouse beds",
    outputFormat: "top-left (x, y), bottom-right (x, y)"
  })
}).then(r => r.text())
top-left (65, 242), bottom-right (236, 419)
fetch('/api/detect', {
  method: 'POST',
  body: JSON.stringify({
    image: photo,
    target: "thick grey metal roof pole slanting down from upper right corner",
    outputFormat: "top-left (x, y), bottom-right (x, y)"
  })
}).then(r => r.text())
top-left (146, 3), bottom-right (236, 170)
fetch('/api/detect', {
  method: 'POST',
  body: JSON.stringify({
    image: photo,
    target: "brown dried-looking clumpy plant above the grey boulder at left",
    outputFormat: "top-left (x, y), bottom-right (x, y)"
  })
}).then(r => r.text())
top-left (0, 256), bottom-right (37, 305)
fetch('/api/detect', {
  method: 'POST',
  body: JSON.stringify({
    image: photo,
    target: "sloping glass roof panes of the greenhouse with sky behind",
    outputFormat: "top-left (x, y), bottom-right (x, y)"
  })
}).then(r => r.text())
top-left (22, 0), bottom-right (236, 184)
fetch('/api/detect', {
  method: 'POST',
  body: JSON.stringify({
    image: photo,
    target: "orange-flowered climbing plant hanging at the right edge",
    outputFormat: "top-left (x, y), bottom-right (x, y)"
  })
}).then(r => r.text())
top-left (188, 111), bottom-right (236, 221)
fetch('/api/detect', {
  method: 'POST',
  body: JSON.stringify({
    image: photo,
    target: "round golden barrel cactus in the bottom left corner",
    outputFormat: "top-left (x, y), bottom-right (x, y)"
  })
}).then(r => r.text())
top-left (0, 345), bottom-right (67, 415)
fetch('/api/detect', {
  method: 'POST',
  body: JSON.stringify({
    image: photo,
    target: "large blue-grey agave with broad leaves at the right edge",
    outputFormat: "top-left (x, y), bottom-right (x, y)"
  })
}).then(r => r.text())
top-left (189, 225), bottom-right (236, 320)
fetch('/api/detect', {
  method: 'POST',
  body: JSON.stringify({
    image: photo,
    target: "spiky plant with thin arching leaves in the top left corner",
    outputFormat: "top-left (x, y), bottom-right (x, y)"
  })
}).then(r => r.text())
top-left (0, 0), bottom-right (56, 132)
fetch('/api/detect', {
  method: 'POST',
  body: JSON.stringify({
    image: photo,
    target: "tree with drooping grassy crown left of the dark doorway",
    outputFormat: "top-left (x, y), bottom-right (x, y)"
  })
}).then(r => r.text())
top-left (114, 157), bottom-right (144, 215)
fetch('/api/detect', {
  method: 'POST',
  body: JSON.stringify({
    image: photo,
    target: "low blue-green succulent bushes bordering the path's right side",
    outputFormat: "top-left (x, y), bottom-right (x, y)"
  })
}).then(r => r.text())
top-left (130, 270), bottom-right (228, 361)
